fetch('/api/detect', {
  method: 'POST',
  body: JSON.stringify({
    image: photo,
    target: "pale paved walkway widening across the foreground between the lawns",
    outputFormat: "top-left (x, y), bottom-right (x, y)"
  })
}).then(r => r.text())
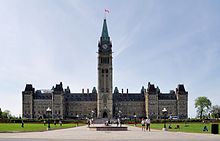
top-left (0, 126), bottom-right (220, 141)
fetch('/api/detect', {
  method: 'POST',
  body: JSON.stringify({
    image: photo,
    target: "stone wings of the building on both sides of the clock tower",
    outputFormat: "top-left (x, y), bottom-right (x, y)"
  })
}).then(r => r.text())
top-left (22, 84), bottom-right (188, 119)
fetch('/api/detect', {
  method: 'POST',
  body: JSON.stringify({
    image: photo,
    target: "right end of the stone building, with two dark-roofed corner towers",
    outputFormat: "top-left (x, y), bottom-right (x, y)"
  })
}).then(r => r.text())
top-left (145, 83), bottom-right (188, 119)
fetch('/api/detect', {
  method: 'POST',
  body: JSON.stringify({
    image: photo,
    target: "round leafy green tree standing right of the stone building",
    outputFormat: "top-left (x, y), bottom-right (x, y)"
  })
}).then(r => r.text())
top-left (195, 96), bottom-right (212, 119)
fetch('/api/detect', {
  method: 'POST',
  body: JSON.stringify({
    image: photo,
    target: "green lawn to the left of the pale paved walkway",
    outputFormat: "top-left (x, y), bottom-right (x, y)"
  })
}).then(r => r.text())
top-left (0, 123), bottom-right (81, 132)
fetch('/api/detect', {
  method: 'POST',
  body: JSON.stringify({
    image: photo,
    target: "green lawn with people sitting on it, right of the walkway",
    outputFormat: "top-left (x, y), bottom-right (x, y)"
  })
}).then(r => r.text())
top-left (135, 123), bottom-right (220, 133)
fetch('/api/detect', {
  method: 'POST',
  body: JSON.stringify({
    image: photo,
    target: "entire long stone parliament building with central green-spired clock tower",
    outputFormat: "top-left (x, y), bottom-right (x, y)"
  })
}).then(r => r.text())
top-left (22, 19), bottom-right (188, 119)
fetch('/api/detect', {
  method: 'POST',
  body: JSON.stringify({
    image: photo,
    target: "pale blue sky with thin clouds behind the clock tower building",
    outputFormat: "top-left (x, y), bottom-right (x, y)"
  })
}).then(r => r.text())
top-left (0, 0), bottom-right (220, 117)
